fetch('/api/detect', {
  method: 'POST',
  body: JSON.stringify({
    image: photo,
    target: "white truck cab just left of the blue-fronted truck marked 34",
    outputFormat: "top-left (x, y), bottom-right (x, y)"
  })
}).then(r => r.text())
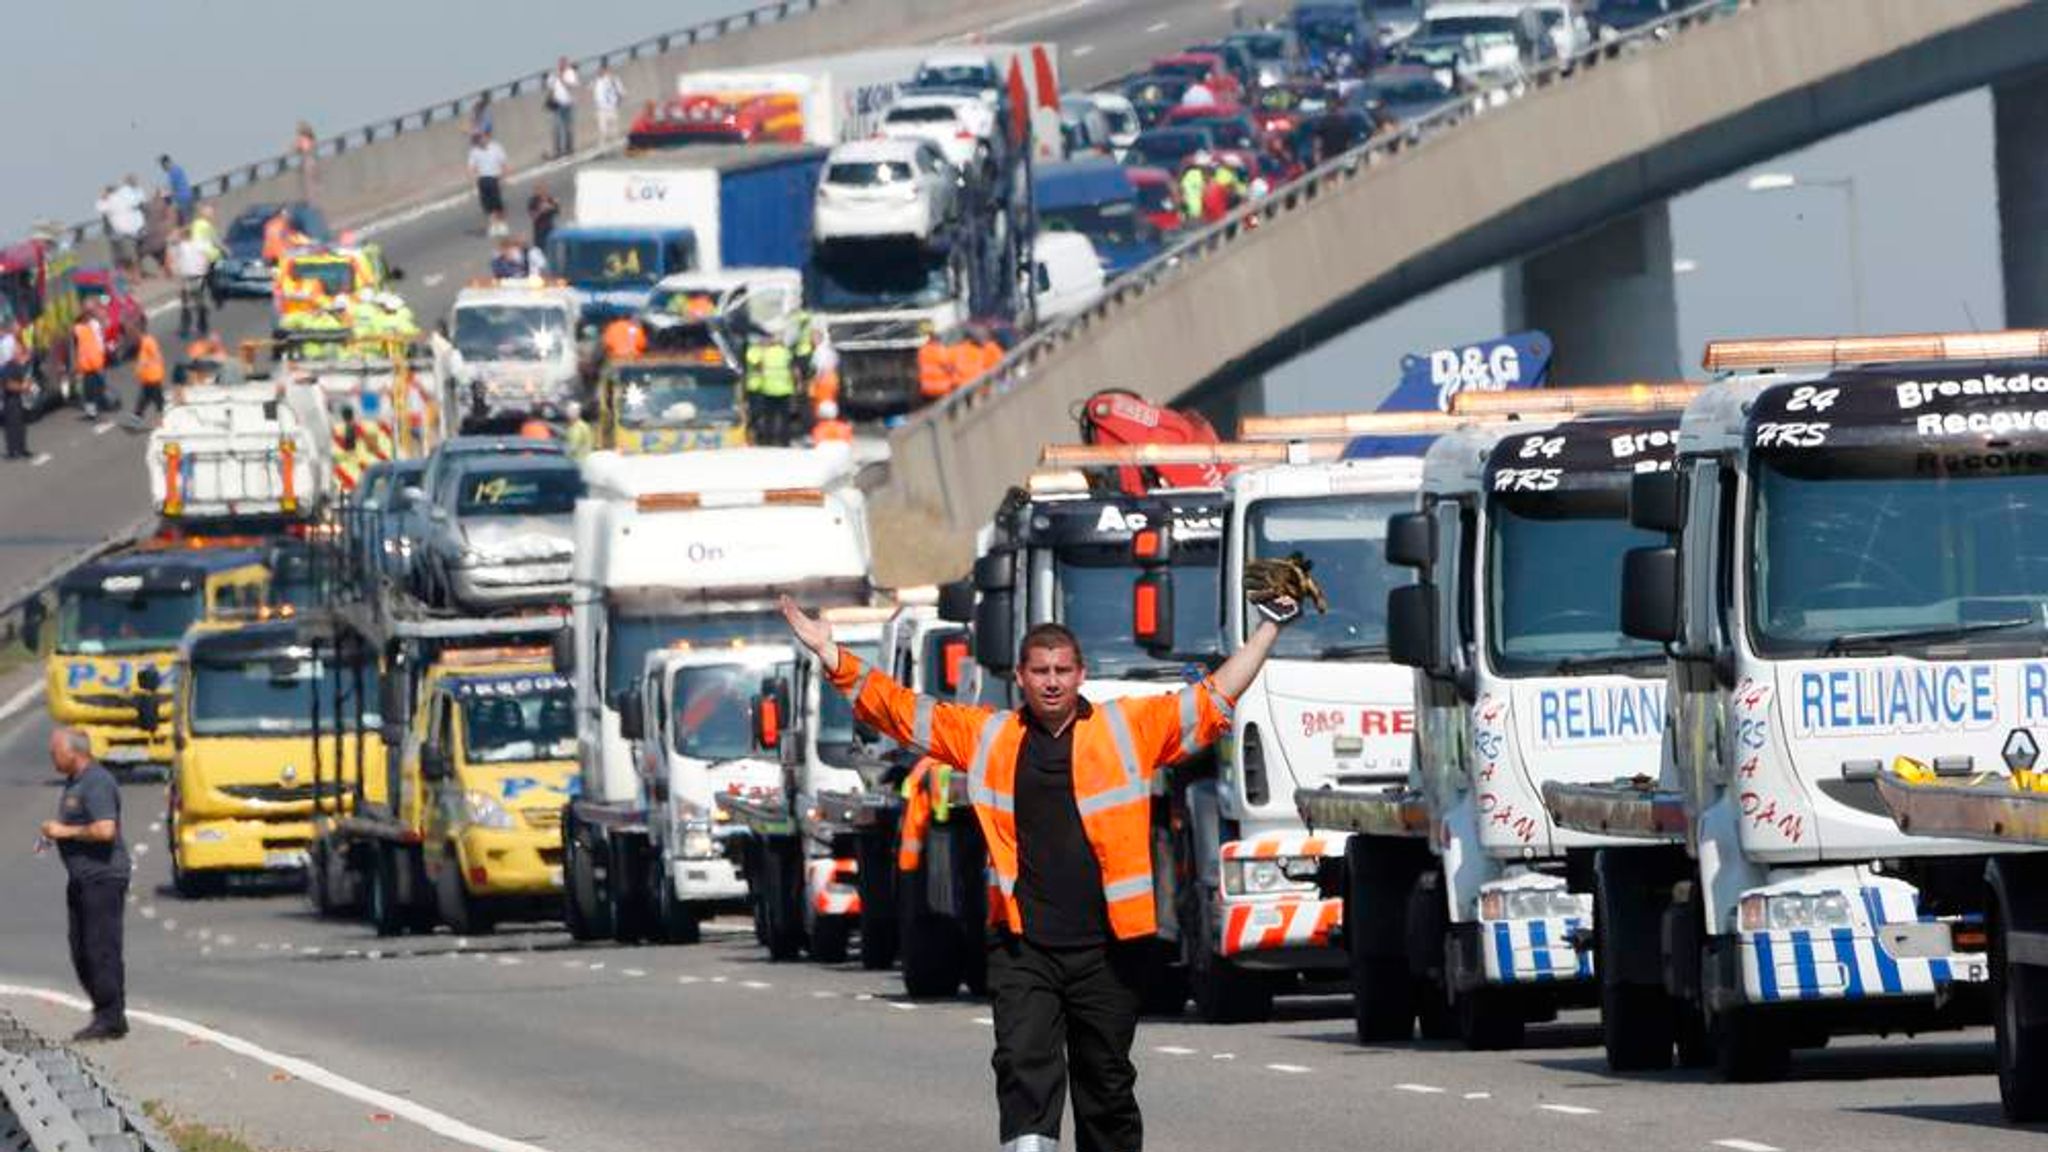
top-left (449, 281), bottom-right (584, 430)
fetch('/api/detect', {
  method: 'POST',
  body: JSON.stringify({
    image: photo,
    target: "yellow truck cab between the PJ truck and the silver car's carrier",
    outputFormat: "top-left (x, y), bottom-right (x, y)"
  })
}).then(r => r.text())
top-left (164, 613), bottom-right (385, 898)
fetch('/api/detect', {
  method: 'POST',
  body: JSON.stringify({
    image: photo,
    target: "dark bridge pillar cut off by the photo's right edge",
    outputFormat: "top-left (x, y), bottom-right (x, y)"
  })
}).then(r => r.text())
top-left (1991, 70), bottom-right (2048, 328)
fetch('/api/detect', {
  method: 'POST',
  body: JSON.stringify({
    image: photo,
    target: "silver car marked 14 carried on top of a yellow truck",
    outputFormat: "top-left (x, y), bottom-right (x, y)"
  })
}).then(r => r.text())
top-left (424, 455), bottom-right (584, 613)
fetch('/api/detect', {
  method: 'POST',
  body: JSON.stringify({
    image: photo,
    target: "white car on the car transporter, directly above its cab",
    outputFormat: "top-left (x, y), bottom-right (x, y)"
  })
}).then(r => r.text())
top-left (813, 139), bottom-right (958, 240)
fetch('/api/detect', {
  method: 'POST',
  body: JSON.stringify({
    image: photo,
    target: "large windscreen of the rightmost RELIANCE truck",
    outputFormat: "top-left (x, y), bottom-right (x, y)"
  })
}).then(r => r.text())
top-left (1749, 455), bottom-right (2048, 656)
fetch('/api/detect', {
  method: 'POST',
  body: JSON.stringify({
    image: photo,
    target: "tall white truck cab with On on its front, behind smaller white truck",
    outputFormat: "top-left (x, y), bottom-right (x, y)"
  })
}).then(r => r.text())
top-left (555, 447), bottom-right (870, 941)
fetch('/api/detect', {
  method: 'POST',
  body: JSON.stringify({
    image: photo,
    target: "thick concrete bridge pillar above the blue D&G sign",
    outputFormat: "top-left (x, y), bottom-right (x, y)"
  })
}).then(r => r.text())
top-left (1501, 203), bottom-right (1683, 383)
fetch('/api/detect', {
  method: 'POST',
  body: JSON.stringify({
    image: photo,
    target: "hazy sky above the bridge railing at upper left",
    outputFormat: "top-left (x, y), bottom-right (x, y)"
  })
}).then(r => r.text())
top-left (0, 0), bottom-right (760, 238)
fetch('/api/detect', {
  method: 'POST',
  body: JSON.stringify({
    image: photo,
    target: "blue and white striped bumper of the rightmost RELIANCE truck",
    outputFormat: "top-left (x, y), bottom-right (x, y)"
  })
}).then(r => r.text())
top-left (1741, 886), bottom-right (1989, 1002)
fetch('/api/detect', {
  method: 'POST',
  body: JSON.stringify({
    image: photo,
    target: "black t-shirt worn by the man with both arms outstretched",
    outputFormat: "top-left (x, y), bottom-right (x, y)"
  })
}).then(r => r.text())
top-left (1016, 701), bottom-right (1110, 947)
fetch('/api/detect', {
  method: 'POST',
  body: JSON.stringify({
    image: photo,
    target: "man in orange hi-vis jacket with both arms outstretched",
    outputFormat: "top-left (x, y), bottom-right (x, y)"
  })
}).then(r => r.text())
top-left (782, 596), bottom-right (1300, 1152)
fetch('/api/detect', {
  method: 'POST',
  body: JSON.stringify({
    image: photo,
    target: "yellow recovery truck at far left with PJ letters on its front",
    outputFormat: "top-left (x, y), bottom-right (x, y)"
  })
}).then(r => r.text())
top-left (34, 547), bottom-right (270, 773)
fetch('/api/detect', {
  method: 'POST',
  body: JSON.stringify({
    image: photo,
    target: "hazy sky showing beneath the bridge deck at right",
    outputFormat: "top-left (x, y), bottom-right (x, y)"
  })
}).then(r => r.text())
top-left (1266, 88), bottom-right (2005, 412)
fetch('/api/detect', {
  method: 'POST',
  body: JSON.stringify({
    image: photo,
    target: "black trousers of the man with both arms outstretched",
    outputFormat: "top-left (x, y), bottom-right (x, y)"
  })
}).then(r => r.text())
top-left (989, 933), bottom-right (1145, 1152)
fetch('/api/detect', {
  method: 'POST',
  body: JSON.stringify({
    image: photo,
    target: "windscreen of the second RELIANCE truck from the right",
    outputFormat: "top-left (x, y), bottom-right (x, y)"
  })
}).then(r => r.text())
top-left (1485, 476), bottom-right (1663, 676)
